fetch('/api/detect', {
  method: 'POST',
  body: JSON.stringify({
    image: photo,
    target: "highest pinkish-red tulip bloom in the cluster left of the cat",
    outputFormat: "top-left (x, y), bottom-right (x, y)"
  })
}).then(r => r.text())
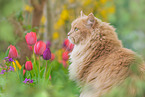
top-left (25, 32), bottom-right (37, 45)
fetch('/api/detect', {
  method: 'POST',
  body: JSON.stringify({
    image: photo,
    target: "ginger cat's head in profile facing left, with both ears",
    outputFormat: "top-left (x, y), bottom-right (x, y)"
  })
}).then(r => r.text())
top-left (68, 11), bottom-right (97, 44)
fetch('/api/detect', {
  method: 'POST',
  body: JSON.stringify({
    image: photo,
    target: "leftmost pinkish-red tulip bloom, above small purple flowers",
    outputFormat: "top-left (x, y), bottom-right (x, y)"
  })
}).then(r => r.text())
top-left (8, 45), bottom-right (18, 58)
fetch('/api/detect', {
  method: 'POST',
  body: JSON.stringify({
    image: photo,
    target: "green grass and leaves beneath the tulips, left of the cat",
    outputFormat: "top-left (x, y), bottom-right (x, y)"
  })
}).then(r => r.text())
top-left (0, 52), bottom-right (79, 97)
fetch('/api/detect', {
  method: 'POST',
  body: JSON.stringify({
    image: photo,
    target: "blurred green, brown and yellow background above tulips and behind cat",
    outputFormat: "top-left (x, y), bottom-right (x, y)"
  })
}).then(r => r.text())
top-left (0, 0), bottom-right (145, 61)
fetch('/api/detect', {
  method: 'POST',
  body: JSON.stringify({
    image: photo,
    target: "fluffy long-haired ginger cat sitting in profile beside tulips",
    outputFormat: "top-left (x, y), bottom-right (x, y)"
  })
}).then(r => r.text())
top-left (68, 12), bottom-right (145, 97)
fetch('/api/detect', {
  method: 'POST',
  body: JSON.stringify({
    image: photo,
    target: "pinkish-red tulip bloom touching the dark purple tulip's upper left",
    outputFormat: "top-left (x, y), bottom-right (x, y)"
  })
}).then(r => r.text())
top-left (34, 41), bottom-right (46, 55)
